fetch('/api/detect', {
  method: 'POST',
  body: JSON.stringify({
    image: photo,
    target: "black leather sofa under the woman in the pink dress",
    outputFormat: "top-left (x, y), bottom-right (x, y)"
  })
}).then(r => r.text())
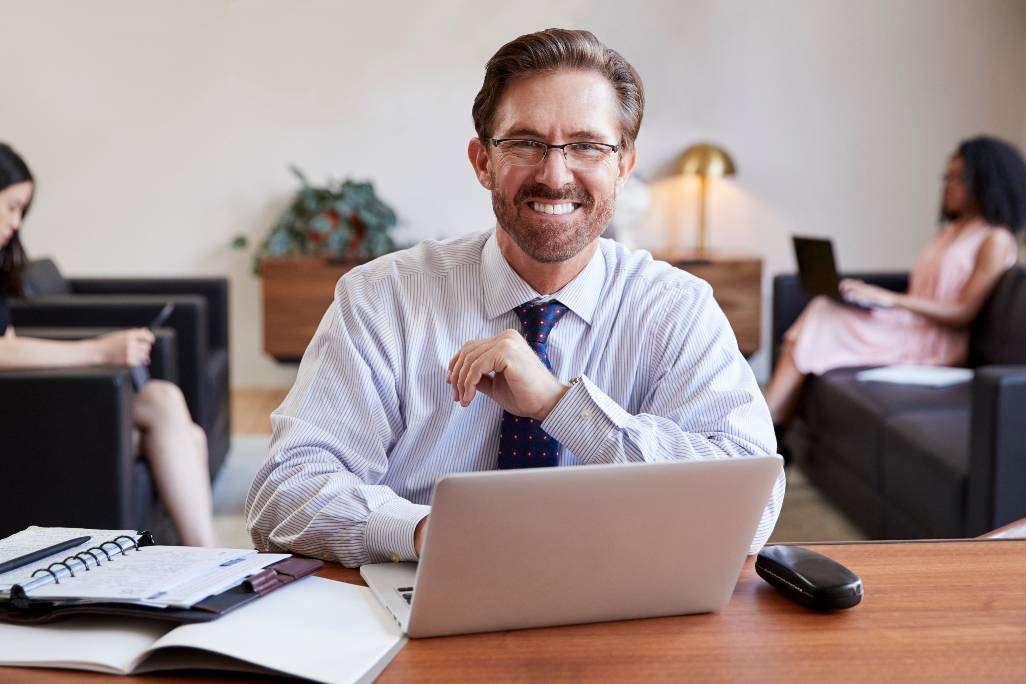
top-left (773, 266), bottom-right (1026, 538)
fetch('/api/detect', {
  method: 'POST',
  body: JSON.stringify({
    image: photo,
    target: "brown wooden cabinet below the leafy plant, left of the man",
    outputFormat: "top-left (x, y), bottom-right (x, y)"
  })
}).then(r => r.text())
top-left (261, 256), bottom-right (359, 363)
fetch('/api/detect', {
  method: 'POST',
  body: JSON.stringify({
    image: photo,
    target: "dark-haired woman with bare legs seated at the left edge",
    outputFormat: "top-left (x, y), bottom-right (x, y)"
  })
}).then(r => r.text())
top-left (0, 144), bottom-right (218, 547)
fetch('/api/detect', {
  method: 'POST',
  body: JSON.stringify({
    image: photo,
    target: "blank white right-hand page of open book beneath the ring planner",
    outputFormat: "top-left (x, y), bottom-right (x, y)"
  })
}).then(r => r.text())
top-left (136, 577), bottom-right (405, 683)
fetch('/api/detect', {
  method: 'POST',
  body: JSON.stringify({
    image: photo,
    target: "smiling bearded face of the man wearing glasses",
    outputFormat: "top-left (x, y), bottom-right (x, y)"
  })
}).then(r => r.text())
top-left (470, 71), bottom-right (634, 264)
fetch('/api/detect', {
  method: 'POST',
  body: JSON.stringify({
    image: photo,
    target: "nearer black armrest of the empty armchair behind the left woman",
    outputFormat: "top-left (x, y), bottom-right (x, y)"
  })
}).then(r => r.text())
top-left (8, 294), bottom-right (209, 425)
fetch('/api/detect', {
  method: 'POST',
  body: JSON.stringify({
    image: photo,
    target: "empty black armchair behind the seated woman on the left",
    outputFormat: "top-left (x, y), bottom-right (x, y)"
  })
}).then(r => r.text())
top-left (8, 258), bottom-right (231, 476)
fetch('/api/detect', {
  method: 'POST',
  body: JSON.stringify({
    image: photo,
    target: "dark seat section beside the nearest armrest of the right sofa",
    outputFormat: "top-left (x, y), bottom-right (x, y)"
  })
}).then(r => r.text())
top-left (882, 409), bottom-right (970, 537)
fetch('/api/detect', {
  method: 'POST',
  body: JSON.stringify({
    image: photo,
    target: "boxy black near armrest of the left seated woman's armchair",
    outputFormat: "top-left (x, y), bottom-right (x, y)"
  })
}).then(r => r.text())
top-left (0, 368), bottom-right (135, 536)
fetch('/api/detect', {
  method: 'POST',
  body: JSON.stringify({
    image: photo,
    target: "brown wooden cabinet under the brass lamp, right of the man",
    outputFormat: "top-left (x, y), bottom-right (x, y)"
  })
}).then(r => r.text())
top-left (653, 249), bottom-right (762, 357)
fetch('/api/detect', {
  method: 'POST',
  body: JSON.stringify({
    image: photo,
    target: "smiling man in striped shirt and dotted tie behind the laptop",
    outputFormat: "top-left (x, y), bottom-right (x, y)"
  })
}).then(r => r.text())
top-left (245, 29), bottom-right (784, 566)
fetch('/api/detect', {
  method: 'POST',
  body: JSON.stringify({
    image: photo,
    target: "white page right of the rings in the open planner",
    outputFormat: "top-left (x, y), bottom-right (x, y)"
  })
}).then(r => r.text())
top-left (29, 547), bottom-right (257, 603)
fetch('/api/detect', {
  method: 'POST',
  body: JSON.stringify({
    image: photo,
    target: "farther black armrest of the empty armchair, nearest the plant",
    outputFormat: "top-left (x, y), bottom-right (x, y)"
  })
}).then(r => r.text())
top-left (68, 278), bottom-right (229, 349)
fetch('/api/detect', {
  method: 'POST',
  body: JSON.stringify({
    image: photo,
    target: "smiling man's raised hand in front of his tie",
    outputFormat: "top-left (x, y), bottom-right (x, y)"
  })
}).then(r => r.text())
top-left (445, 329), bottom-right (569, 420)
